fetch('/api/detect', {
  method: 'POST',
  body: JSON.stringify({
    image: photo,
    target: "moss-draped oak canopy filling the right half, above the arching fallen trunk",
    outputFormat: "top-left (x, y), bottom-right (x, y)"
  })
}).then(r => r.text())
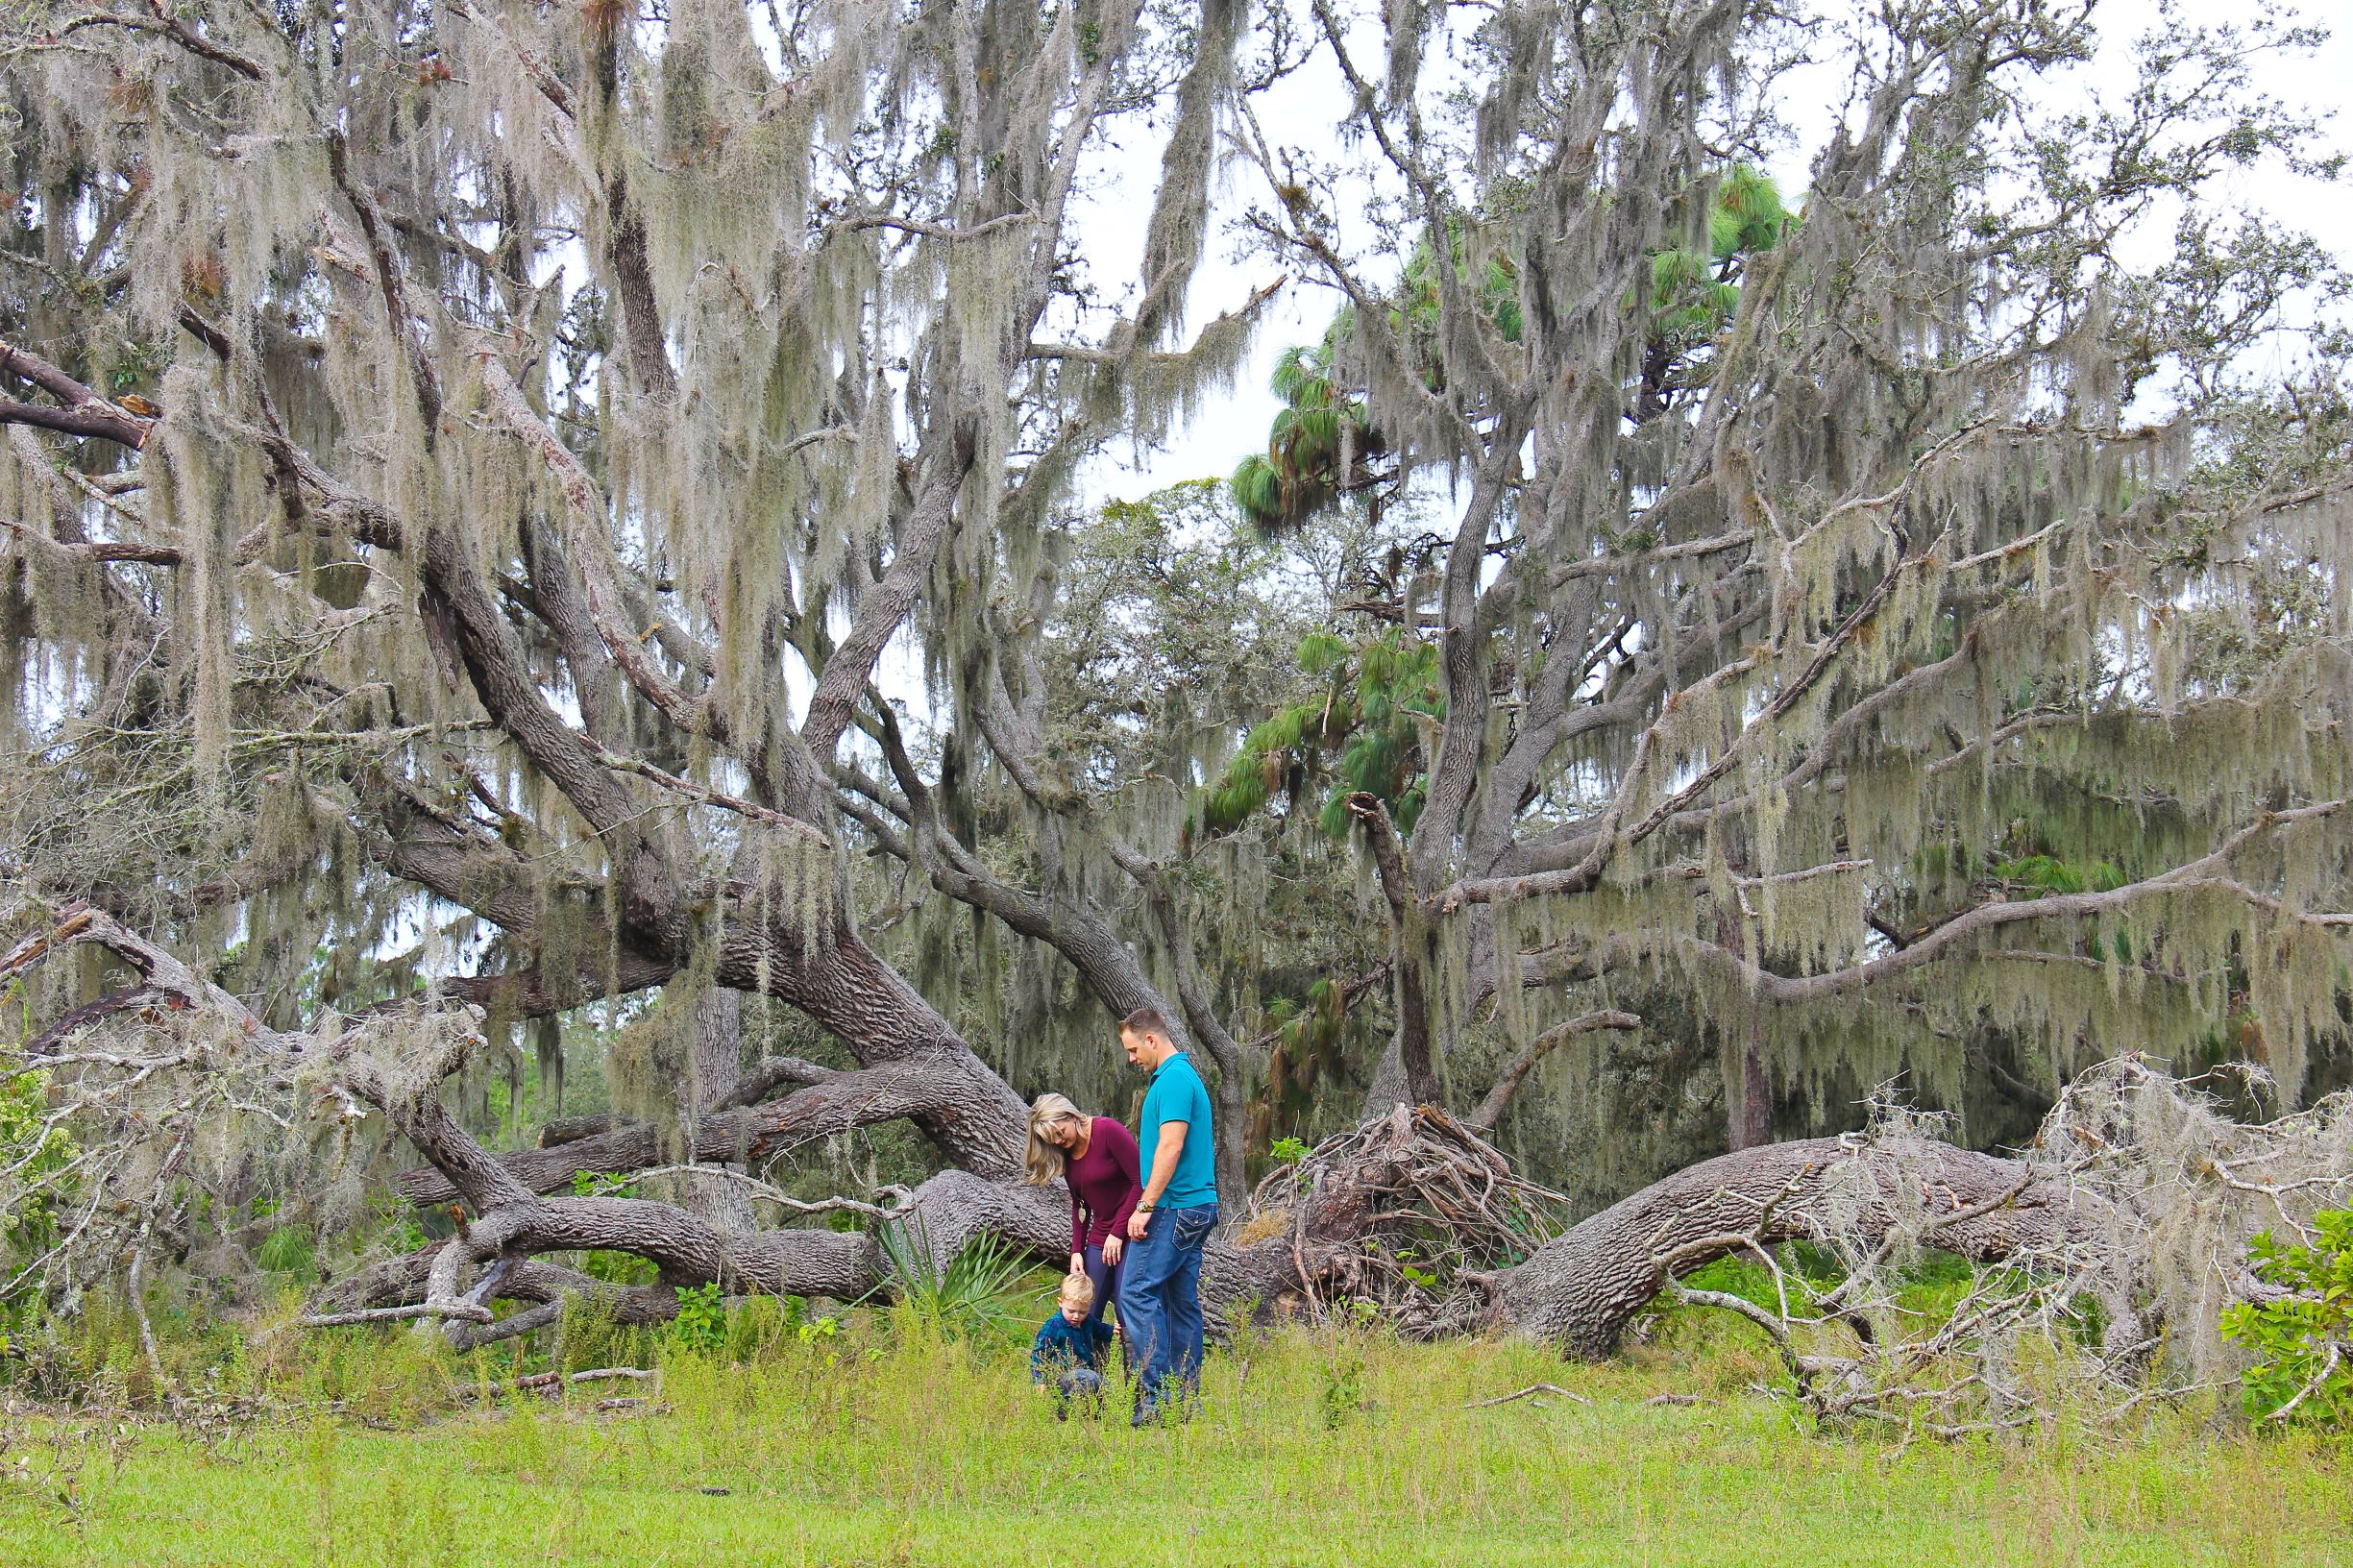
top-left (1202, 5), bottom-right (2346, 1146)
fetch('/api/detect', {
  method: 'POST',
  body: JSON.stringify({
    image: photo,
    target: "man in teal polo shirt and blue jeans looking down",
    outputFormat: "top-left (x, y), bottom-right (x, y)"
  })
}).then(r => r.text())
top-left (1120, 1008), bottom-right (1216, 1427)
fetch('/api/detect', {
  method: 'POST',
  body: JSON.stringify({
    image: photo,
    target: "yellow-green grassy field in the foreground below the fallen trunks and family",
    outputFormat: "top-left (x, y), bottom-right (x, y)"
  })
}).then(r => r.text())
top-left (0, 1321), bottom-right (2353, 1568)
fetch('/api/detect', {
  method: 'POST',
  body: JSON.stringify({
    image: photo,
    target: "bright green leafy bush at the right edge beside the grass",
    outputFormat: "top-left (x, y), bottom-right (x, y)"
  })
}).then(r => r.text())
top-left (2221, 1208), bottom-right (2353, 1427)
